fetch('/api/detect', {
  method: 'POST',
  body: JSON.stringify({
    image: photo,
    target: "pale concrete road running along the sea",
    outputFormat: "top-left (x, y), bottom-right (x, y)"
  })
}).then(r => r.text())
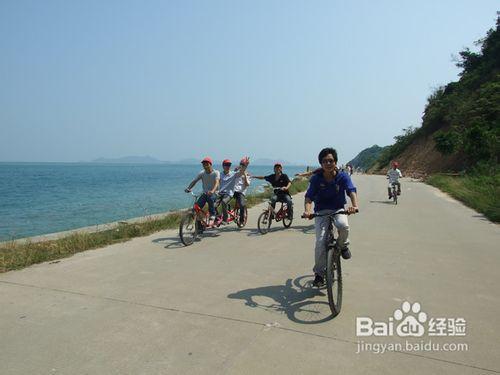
top-left (0, 176), bottom-right (500, 375)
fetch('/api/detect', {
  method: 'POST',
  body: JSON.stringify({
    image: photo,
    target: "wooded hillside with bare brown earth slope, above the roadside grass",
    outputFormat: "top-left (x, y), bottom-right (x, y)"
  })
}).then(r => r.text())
top-left (370, 17), bottom-right (500, 174)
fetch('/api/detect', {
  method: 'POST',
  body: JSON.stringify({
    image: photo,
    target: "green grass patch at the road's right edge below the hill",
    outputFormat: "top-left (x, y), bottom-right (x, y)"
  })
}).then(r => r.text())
top-left (425, 172), bottom-right (500, 223)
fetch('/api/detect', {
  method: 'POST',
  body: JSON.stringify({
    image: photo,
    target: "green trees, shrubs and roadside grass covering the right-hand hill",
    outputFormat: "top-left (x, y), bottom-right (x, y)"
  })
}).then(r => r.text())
top-left (368, 16), bottom-right (500, 222)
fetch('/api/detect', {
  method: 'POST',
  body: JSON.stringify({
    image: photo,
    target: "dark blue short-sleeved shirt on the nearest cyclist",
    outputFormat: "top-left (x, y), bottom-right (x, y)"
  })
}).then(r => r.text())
top-left (306, 172), bottom-right (356, 212)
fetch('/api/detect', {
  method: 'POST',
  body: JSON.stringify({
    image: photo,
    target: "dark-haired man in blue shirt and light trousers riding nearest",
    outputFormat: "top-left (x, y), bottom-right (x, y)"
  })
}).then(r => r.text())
top-left (303, 147), bottom-right (358, 287)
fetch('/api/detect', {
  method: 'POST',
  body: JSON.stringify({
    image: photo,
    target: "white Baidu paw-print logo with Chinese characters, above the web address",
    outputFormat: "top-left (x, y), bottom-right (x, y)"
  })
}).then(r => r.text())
top-left (356, 301), bottom-right (466, 337)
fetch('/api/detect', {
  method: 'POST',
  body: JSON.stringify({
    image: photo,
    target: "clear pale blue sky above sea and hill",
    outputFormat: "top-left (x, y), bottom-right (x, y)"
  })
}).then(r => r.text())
top-left (0, 0), bottom-right (500, 164)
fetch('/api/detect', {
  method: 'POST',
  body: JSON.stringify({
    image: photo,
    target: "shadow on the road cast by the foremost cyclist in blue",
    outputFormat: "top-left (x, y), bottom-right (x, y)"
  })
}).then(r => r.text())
top-left (227, 275), bottom-right (333, 324)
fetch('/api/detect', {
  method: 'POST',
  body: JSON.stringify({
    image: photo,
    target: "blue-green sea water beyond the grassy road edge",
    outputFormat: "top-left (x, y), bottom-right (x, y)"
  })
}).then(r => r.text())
top-left (0, 163), bottom-right (305, 241)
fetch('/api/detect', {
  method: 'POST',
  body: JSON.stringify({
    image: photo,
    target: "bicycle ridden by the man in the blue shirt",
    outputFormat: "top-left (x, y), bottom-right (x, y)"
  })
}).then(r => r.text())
top-left (302, 210), bottom-right (358, 317)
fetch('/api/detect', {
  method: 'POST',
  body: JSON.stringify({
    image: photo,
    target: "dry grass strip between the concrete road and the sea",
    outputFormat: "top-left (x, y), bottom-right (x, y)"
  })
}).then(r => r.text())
top-left (0, 179), bottom-right (308, 273)
